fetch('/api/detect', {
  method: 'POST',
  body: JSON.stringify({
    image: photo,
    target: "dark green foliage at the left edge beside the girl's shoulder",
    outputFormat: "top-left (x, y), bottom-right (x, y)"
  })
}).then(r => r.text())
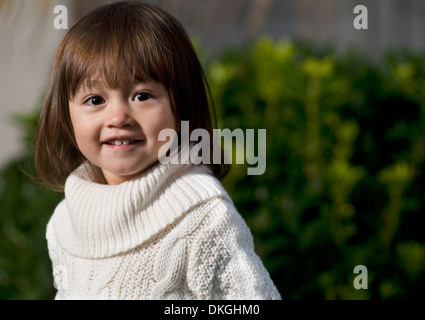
top-left (0, 110), bottom-right (60, 300)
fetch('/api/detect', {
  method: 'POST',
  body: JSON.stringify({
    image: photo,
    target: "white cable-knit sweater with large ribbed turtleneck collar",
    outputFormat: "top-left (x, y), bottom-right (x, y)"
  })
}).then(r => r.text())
top-left (46, 164), bottom-right (280, 299)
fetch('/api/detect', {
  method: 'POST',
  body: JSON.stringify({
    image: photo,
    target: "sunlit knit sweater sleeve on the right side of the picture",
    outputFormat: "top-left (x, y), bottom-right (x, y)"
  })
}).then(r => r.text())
top-left (188, 200), bottom-right (281, 300)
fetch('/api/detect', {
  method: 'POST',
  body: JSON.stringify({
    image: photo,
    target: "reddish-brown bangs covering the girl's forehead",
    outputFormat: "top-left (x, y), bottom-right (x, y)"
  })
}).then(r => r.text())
top-left (64, 4), bottom-right (172, 99)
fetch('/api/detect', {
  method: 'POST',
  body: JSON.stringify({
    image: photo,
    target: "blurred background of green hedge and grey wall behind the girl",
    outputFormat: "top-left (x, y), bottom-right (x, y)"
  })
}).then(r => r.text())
top-left (0, 0), bottom-right (425, 300)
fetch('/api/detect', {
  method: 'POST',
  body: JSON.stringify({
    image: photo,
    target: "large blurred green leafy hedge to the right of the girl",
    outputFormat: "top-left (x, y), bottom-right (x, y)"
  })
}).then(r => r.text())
top-left (207, 38), bottom-right (425, 299)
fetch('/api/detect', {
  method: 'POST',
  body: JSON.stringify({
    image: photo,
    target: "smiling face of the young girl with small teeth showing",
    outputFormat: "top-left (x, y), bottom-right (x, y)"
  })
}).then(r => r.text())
top-left (69, 80), bottom-right (176, 184)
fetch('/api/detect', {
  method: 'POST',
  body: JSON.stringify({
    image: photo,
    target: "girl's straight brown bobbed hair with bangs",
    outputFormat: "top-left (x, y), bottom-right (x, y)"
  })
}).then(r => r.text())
top-left (35, 1), bottom-right (230, 190)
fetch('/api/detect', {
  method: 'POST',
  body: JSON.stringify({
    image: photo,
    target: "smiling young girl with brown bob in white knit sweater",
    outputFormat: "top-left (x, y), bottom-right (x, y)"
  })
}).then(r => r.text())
top-left (35, 2), bottom-right (280, 299)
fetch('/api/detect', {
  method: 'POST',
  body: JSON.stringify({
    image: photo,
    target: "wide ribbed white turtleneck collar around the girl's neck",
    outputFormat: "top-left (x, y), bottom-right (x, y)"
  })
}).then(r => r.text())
top-left (53, 159), bottom-right (227, 258)
